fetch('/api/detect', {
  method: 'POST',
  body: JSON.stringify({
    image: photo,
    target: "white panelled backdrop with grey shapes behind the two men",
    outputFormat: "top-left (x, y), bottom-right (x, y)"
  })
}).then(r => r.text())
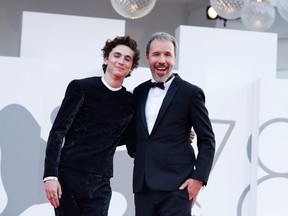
top-left (0, 12), bottom-right (288, 216)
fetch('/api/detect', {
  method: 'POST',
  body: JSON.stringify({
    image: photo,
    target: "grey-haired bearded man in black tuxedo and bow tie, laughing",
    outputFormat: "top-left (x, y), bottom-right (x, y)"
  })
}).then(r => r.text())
top-left (127, 32), bottom-right (215, 216)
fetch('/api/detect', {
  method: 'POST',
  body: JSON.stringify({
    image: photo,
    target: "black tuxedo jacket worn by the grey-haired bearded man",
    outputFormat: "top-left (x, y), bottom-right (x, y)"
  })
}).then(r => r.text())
top-left (128, 74), bottom-right (215, 193)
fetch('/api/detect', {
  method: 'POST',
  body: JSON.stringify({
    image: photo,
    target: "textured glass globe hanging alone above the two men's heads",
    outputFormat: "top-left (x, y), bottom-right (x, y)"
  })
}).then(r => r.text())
top-left (110, 0), bottom-right (157, 19)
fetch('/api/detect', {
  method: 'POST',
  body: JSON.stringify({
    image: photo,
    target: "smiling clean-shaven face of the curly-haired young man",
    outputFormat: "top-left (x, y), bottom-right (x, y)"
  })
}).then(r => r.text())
top-left (104, 45), bottom-right (134, 78)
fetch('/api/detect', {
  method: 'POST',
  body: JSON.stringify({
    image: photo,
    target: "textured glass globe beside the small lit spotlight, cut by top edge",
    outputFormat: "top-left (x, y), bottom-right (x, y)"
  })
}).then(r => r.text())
top-left (210, 0), bottom-right (245, 19)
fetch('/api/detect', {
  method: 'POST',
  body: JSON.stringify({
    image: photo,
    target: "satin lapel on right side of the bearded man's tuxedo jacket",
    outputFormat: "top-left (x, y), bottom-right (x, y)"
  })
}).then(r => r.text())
top-left (151, 76), bottom-right (181, 134)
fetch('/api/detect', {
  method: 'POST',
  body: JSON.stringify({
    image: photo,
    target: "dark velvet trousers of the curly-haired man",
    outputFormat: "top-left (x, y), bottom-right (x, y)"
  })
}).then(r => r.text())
top-left (55, 167), bottom-right (112, 216)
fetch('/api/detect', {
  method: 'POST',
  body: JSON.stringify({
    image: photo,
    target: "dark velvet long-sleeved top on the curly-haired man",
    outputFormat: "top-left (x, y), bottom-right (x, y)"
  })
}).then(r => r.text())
top-left (44, 77), bottom-right (135, 177)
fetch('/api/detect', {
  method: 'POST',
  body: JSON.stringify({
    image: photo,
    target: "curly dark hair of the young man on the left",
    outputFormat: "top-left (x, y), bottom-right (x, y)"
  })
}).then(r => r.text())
top-left (101, 36), bottom-right (140, 76)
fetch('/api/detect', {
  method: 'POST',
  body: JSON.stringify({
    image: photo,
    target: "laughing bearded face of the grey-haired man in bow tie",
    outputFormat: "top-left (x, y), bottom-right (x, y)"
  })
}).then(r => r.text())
top-left (146, 40), bottom-right (176, 82)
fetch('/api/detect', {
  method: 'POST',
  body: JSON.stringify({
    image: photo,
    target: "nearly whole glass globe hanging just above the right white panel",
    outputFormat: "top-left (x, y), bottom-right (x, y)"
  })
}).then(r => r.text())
top-left (241, 0), bottom-right (275, 31)
